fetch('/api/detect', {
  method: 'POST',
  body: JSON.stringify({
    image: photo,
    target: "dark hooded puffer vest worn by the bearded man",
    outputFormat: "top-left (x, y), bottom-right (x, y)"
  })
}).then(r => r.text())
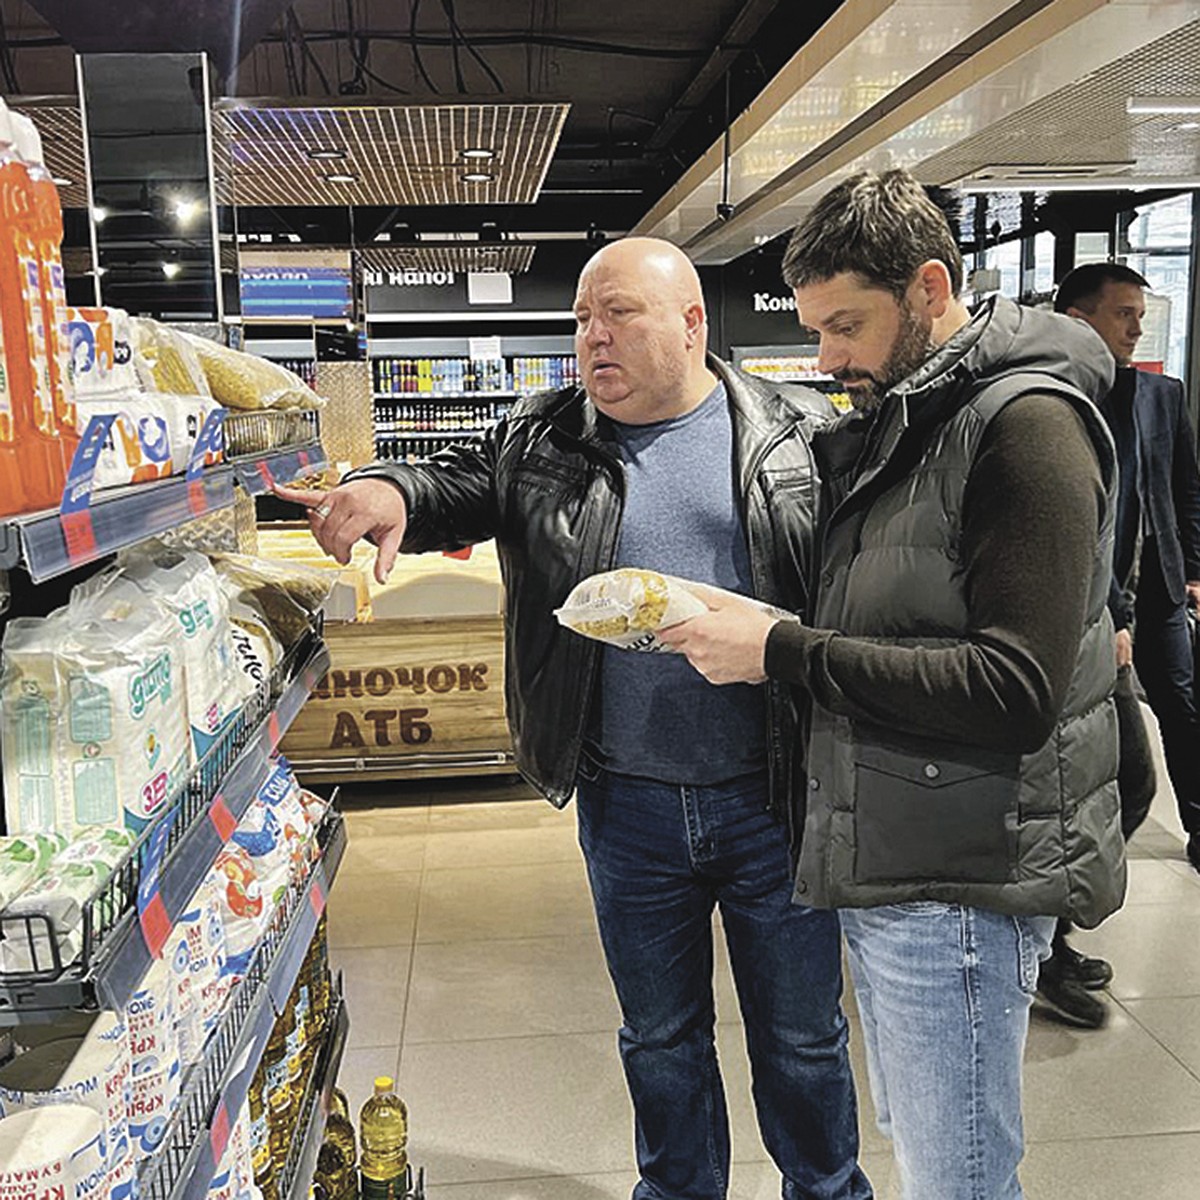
top-left (797, 299), bottom-right (1124, 926)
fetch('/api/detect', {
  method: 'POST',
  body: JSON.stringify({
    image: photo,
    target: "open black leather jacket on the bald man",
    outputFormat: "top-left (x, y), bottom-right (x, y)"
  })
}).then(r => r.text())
top-left (348, 358), bottom-right (832, 818)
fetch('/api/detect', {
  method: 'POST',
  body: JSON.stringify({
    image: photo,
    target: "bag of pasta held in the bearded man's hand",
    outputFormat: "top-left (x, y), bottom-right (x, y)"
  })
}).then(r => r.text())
top-left (554, 566), bottom-right (708, 653)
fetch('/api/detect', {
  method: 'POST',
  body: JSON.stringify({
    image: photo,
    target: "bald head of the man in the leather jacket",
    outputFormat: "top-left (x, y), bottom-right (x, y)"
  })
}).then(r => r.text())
top-left (575, 238), bottom-right (715, 425)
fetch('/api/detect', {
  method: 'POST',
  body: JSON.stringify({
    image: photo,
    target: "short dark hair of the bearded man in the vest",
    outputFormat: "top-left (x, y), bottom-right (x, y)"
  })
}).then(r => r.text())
top-left (784, 170), bottom-right (962, 300)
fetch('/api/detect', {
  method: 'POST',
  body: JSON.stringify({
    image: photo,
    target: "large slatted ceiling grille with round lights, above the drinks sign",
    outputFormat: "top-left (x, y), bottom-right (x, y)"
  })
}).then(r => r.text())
top-left (215, 101), bottom-right (569, 208)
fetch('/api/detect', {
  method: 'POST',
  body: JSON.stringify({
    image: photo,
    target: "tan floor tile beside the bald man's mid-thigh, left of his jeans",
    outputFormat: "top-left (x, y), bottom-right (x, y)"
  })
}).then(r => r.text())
top-left (416, 862), bottom-right (595, 942)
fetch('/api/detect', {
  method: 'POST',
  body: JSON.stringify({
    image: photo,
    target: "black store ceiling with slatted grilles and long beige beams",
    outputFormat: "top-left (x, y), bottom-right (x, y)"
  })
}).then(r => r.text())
top-left (0, 0), bottom-right (1200, 274)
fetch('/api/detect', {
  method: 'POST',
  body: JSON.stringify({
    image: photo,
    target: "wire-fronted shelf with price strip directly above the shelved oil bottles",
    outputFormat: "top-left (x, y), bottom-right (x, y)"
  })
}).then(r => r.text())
top-left (138, 805), bottom-right (346, 1200)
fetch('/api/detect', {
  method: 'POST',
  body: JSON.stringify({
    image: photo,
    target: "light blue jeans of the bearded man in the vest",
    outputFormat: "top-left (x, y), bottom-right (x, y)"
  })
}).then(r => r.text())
top-left (841, 900), bottom-right (1055, 1200)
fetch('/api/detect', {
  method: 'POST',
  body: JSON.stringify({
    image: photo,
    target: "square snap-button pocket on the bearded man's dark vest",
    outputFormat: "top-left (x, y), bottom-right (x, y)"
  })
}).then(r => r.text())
top-left (854, 745), bottom-right (1020, 883)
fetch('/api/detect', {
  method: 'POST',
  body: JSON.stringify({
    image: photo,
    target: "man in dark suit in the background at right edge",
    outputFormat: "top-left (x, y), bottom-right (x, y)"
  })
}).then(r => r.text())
top-left (1038, 263), bottom-right (1200, 1027)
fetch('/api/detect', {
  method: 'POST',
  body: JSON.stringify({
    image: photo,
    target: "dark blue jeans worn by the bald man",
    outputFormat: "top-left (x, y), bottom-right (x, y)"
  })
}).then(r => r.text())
top-left (576, 757), bottom-right (871, 1200)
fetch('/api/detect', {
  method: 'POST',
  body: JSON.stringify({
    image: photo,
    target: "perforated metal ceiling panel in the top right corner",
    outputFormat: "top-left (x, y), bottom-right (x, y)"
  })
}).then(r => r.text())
top-left (919, 22), bottom-right (1200, 184)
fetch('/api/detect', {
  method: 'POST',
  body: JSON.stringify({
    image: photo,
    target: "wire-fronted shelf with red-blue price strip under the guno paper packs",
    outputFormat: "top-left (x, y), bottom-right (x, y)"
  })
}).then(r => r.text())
top-left (0, 631), bottom-right (329, 1026)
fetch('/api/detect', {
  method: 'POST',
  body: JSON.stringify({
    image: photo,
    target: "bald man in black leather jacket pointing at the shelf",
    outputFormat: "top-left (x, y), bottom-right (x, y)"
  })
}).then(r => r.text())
top-left (280, 238), bottom-right (871, 1200)
